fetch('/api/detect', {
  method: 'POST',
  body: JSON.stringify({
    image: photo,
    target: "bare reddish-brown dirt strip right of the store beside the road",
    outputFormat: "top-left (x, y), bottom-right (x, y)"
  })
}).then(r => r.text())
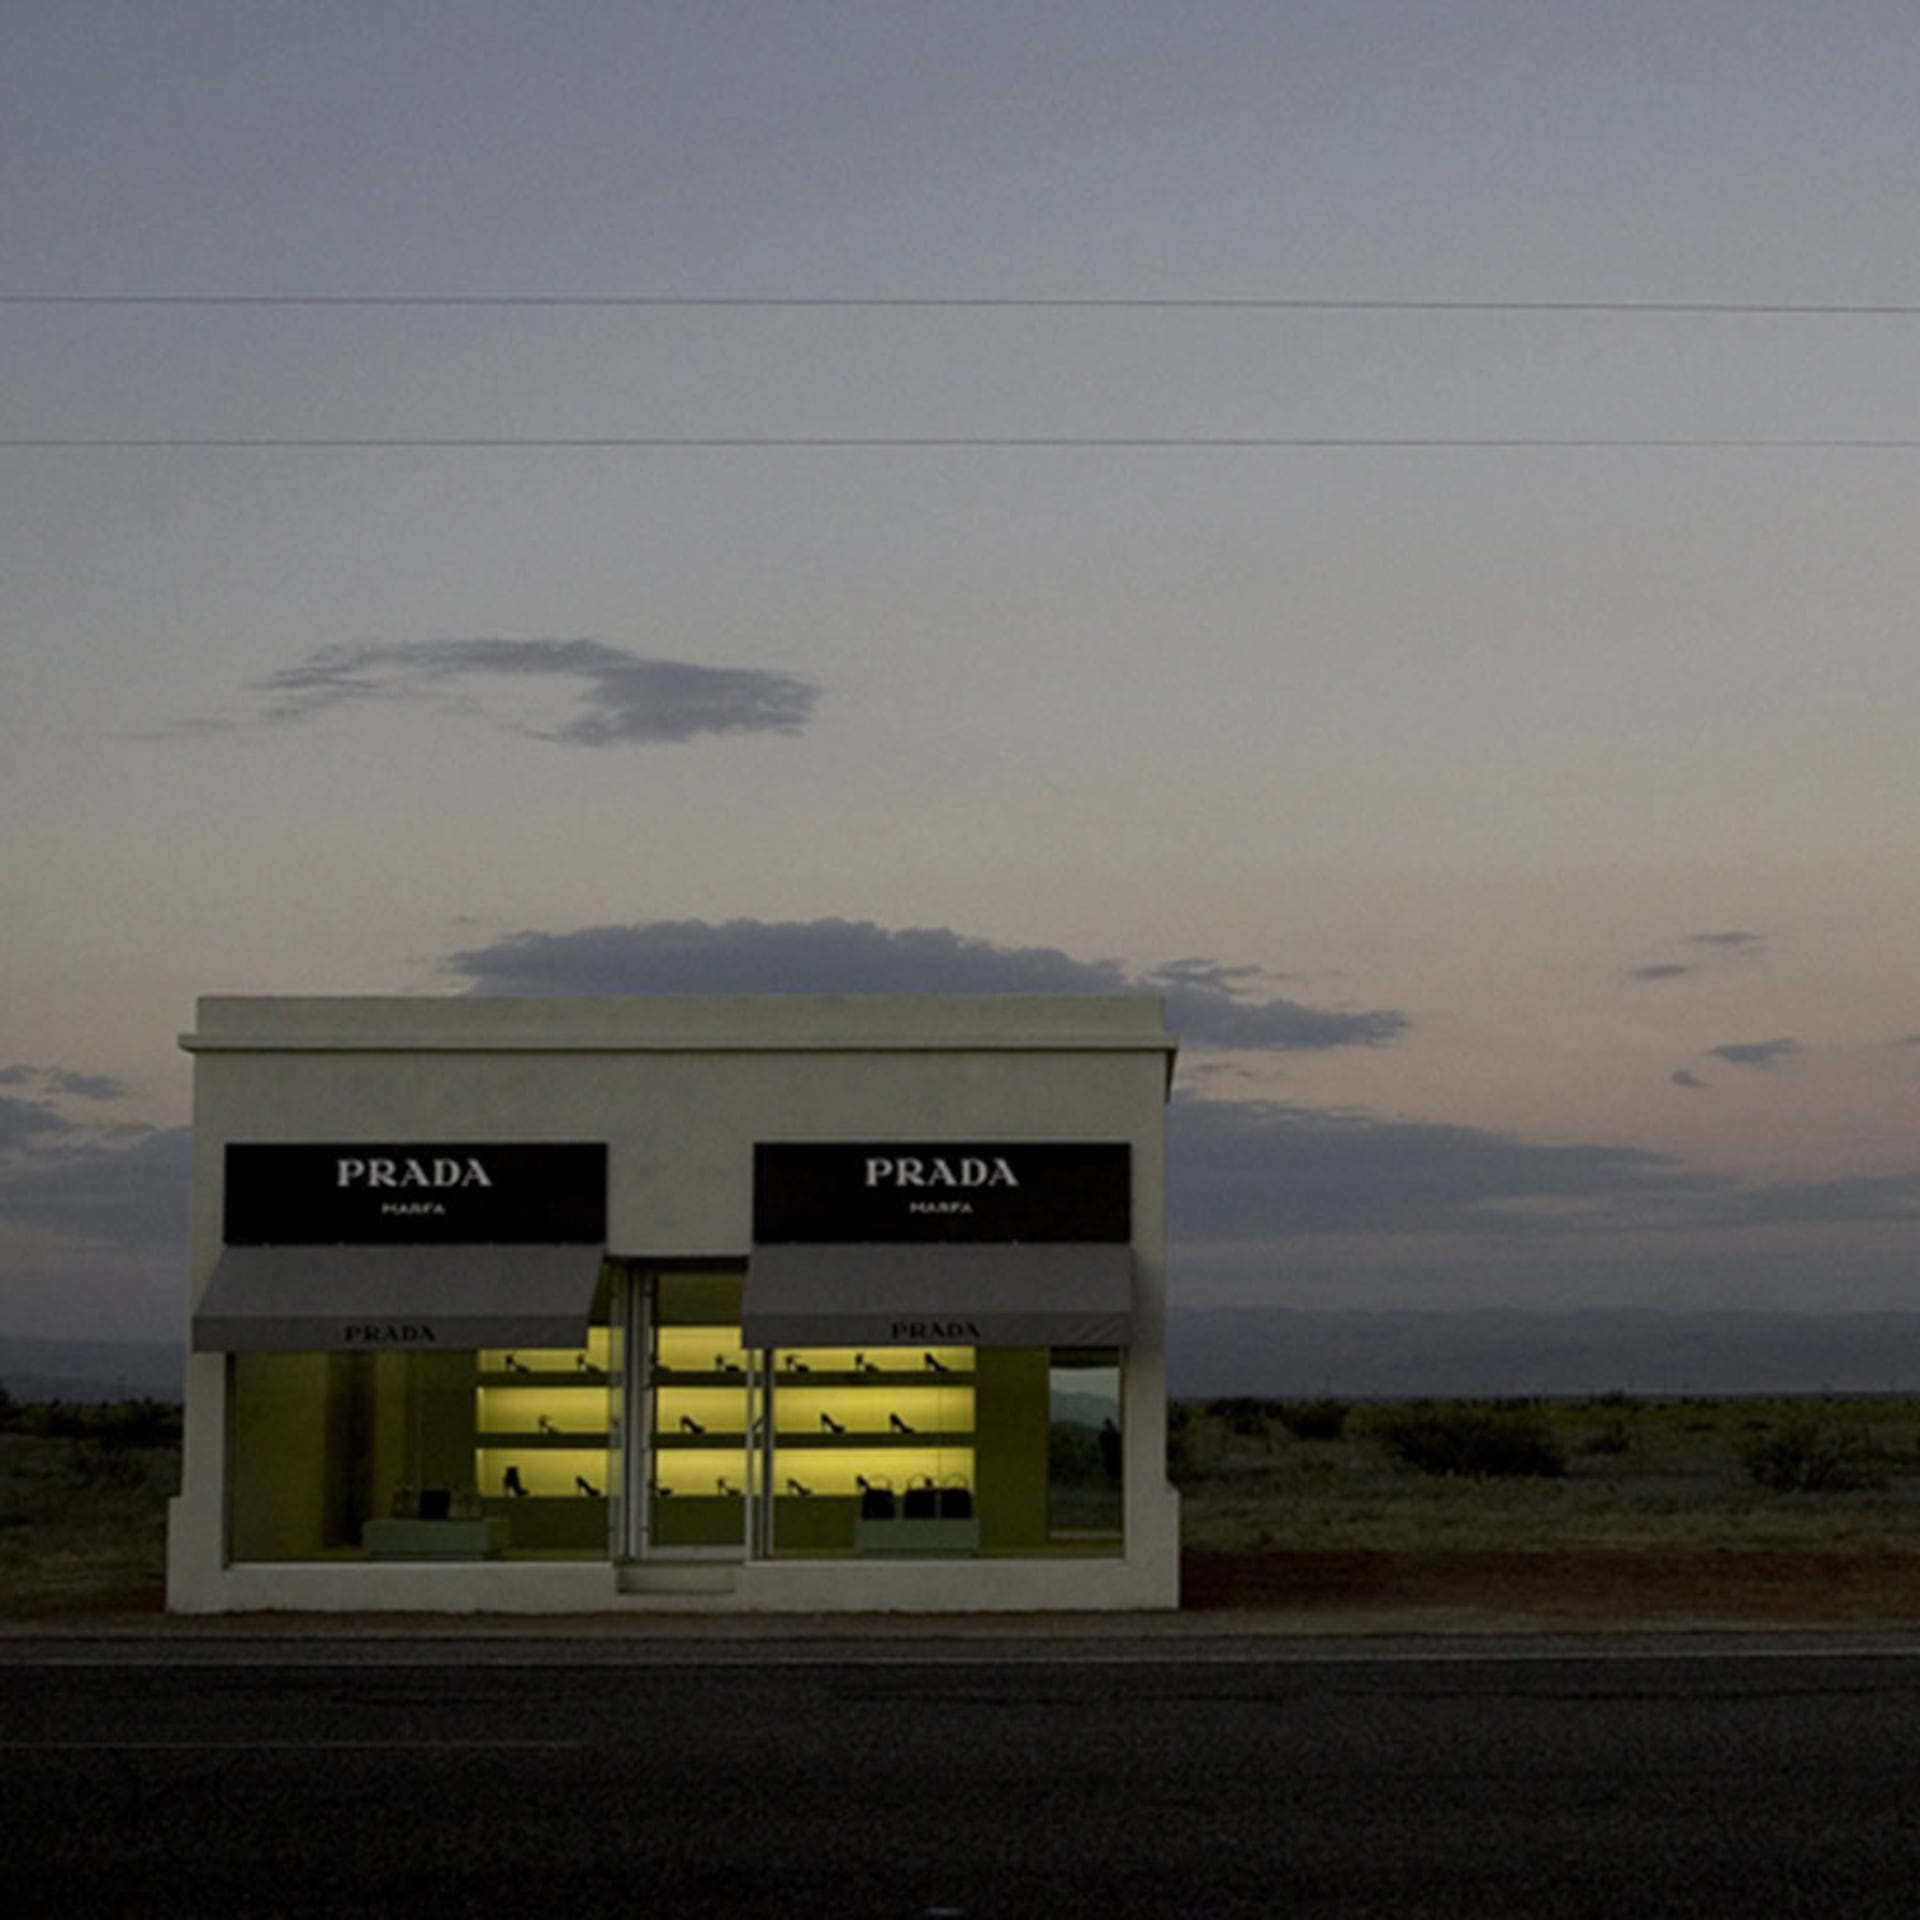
top-left (1181, 1548), bottom-right (1920, 1630)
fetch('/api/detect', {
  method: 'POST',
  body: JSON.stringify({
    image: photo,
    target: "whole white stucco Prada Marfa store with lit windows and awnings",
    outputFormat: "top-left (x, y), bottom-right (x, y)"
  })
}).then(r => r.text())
top-left (167, 996), bottom-right (1179, 1613)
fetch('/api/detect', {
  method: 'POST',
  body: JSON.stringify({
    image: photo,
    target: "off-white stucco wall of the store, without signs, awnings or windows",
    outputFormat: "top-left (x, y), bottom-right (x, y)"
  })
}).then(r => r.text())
top-left (167, 996), bottom-right (1179, 1613)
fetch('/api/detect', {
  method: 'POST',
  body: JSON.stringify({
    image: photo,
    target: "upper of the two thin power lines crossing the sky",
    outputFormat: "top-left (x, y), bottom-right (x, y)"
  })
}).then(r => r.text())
top-left (11, 294), bottom-right (1920, 319)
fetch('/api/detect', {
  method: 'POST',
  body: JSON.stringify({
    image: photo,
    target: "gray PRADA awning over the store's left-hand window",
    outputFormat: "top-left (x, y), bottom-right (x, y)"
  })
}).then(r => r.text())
top-left (194, 1246), bottom-right (601, 1354)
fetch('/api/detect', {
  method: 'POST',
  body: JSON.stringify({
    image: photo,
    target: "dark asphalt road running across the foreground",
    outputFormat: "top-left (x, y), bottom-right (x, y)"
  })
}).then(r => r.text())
top-left (0, 1642), bottom-right (1920, 1920)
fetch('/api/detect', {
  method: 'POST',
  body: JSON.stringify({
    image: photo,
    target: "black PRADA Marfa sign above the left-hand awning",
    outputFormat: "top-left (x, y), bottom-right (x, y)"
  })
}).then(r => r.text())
top-left (227, 1140), bottom-right (607, 1246)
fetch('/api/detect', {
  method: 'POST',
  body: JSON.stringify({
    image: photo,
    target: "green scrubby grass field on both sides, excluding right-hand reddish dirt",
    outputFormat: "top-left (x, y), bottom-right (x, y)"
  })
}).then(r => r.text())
top-left (11, 1396), bottom-right (1920, 1620)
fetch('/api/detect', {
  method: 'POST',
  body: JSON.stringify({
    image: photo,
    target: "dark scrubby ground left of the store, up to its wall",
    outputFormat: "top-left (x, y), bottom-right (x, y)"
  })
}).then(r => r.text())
top-left (0, 1388), bottom-right (180, 1619)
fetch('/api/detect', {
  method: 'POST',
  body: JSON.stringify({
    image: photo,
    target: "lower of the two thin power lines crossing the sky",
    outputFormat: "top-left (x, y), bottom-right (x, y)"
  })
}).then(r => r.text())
top-left (11, 434), bottom-right (1920, 453)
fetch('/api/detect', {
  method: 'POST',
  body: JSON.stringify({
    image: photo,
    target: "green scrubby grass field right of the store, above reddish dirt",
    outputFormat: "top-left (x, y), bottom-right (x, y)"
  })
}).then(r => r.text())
top-left (1171, 1394), bottom-right (1920, 1553)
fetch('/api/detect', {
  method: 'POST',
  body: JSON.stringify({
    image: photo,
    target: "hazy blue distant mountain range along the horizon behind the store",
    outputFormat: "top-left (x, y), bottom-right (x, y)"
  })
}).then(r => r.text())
top-left (18, 1308), bottom-right (1920, 1400)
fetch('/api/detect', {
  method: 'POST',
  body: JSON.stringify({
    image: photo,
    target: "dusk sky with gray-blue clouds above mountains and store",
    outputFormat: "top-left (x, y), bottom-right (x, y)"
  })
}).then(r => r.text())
top-left (0, 0), bottom-right (1920, 1338)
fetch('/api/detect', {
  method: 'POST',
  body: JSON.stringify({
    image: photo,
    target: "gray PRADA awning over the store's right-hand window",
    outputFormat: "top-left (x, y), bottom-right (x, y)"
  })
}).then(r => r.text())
top-left (741, 1242), bottom-right (1133, 1348)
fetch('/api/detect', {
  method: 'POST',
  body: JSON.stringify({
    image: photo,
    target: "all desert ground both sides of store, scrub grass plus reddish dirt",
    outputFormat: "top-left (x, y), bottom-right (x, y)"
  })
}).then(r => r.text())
top-left (18, 1394), bottom-right (1920, 1632)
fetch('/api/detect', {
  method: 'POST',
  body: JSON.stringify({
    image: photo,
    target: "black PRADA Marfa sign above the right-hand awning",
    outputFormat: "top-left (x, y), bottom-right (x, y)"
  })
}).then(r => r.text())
top-left (753, 1140), bottom-right (1133, 1246)
